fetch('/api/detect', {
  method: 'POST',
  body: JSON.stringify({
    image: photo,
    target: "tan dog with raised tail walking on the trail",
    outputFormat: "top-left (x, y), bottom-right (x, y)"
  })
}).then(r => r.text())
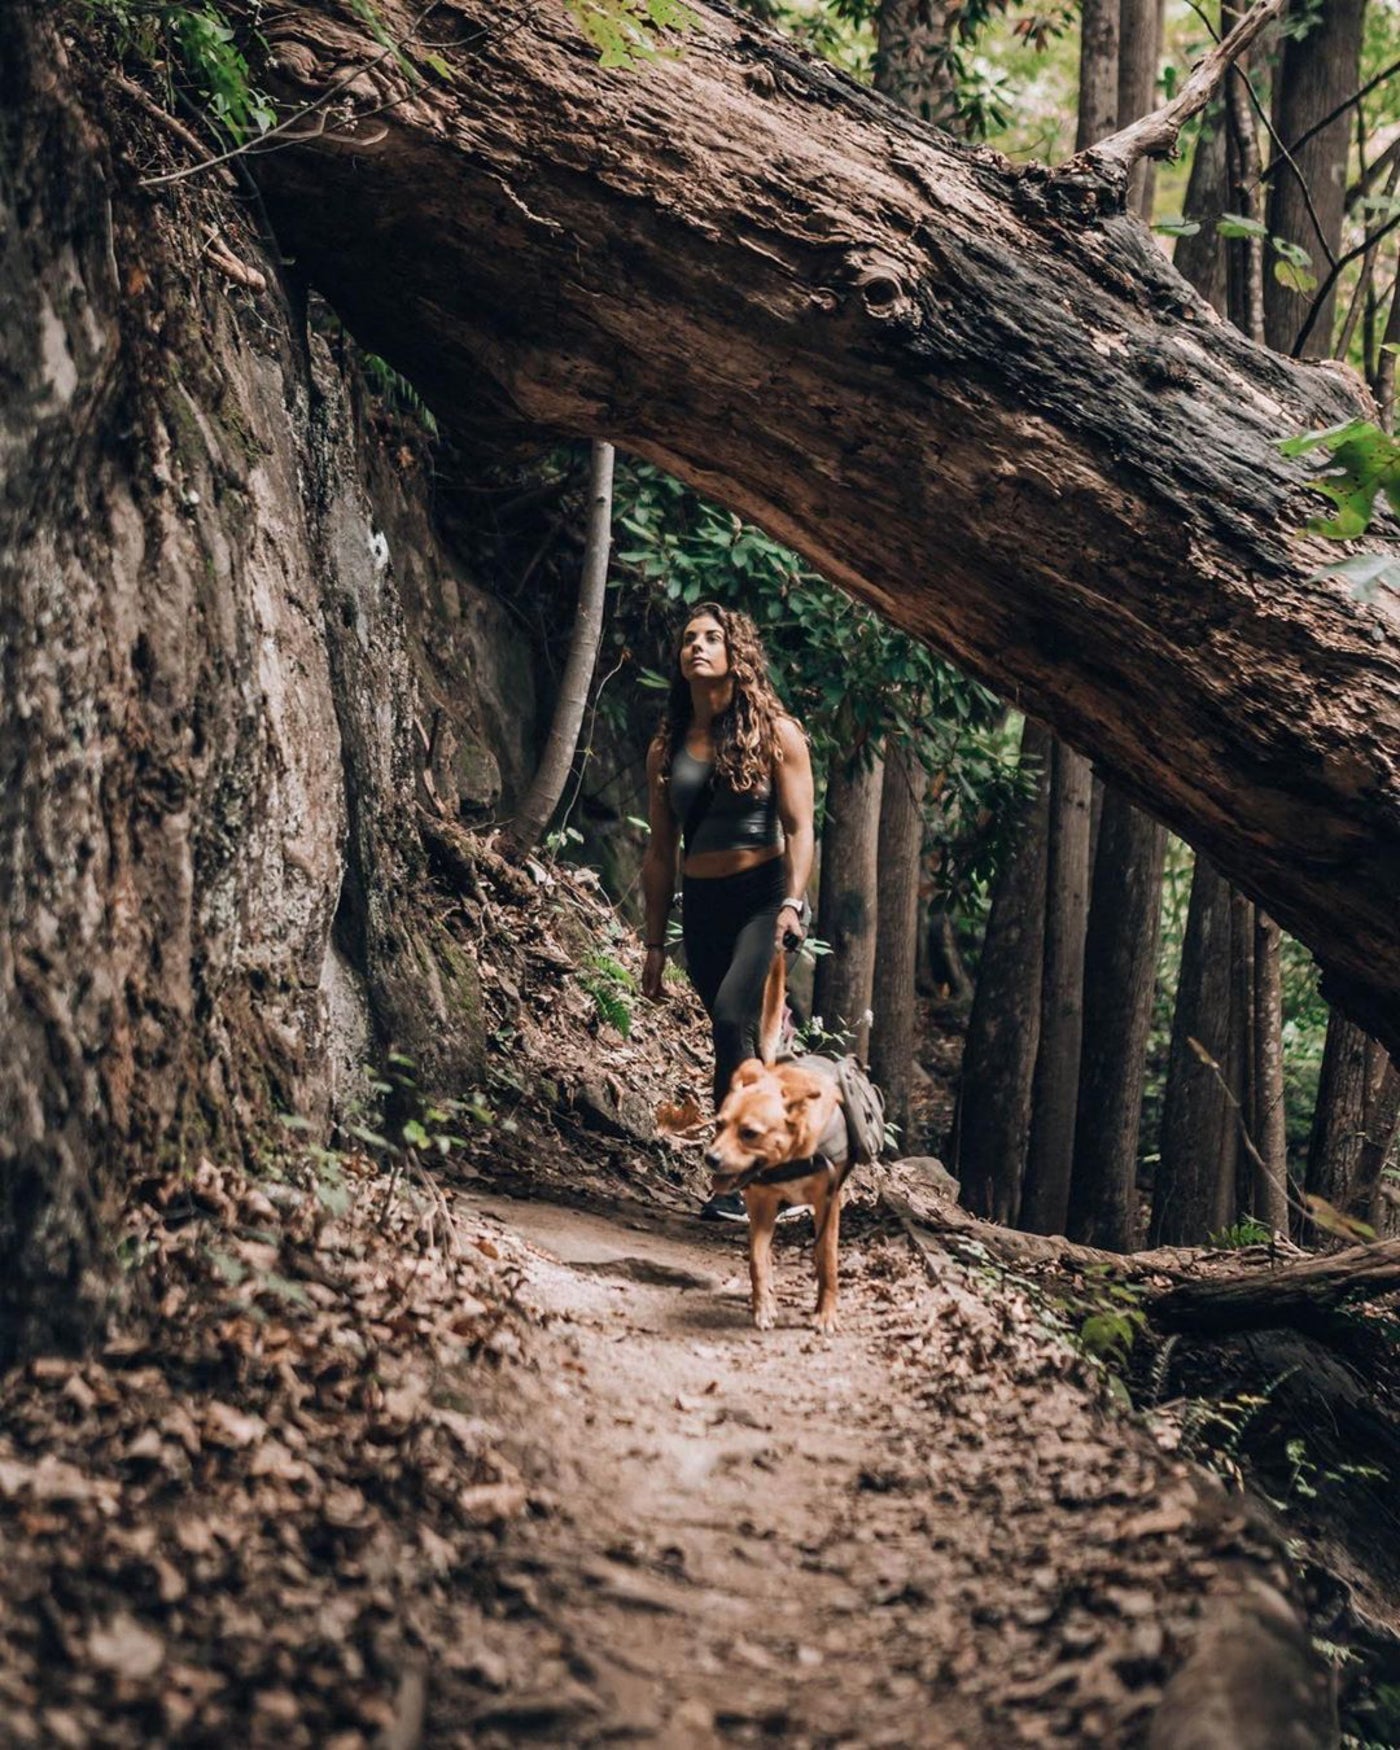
top-left (705, 954), bottom-right (847, 1332)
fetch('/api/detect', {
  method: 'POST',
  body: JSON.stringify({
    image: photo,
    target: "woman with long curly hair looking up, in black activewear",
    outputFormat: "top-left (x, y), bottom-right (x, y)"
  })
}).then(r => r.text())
top-left (642, 602), bottom-right (814, 1220)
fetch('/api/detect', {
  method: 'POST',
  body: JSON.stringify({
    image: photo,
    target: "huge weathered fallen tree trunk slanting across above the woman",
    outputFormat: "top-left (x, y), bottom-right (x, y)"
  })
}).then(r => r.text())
top-left (232, 0), bottom-right (1400, 1048)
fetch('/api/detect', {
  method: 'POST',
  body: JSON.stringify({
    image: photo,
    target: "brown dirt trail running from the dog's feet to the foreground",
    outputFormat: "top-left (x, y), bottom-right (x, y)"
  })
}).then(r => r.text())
top-left (448, 1195), bottom-right (1302, 1750)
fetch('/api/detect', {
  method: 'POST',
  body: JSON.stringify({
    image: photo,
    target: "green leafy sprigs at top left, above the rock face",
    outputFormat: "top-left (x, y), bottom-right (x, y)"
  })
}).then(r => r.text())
top-left (79, 0), bottom-right (277, 145)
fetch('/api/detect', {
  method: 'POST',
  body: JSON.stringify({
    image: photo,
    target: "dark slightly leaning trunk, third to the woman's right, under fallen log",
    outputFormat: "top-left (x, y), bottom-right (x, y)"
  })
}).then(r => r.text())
top-left (954, 719), bottom-right (1054, 1222)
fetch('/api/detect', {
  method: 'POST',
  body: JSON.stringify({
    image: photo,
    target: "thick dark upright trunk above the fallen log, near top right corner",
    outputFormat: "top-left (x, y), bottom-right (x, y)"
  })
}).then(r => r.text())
top-left (1264, 0), bottom-right (1365, 359)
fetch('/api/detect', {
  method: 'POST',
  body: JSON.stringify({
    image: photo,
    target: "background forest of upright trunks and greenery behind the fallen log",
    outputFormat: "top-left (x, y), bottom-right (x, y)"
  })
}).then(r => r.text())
top-left (451, 0), bottom-right (1400, 1248)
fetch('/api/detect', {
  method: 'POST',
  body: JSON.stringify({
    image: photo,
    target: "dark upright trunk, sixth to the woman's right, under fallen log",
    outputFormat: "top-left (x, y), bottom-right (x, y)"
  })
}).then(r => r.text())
top-left (1148, 858), bottom-right (1236, 1246)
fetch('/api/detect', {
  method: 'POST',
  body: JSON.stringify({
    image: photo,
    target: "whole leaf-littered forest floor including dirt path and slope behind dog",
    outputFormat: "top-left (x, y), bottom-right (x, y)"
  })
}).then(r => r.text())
top-left (0, 843), bottom-right (1390, 1750)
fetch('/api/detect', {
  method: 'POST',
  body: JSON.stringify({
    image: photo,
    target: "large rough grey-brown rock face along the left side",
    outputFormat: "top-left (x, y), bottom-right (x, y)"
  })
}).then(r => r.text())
top-left (0, 7), bottom-right (530, 1355)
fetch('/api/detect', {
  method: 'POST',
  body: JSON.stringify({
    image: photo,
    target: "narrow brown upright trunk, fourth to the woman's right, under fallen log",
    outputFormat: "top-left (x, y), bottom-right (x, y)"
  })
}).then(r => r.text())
top-left (1020, 744), bottom-right (1094, 1234)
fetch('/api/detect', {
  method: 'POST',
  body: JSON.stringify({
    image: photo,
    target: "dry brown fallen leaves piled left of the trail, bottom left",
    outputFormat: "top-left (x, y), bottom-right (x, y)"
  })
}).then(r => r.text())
top-left (0, 1159), bottom-right (548, 1750)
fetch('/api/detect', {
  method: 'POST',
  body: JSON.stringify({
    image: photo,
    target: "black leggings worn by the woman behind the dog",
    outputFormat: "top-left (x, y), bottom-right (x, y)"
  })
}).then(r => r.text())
top-left (681, 858), bottom-right (788, 1111)
